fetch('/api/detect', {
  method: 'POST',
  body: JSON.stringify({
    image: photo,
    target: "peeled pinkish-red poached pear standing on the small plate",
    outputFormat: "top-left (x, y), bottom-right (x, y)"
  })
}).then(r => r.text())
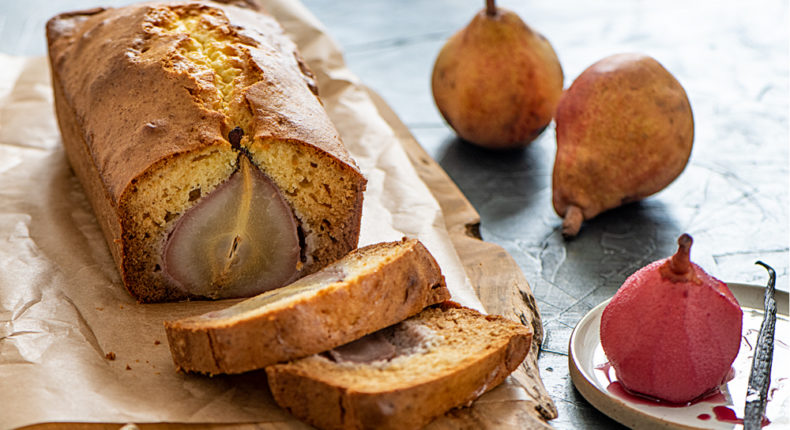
top-left (601, 234), bottom-right (743, 404)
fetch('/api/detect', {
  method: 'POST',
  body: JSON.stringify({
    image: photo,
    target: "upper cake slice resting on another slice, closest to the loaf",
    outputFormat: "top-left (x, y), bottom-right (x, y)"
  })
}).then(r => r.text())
top-left (165, 239), bottom-right (450, 374)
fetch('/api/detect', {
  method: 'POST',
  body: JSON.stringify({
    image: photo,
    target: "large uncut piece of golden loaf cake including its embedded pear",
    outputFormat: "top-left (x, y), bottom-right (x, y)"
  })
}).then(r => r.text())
top-left (47, 2), bottom-right (366, 302)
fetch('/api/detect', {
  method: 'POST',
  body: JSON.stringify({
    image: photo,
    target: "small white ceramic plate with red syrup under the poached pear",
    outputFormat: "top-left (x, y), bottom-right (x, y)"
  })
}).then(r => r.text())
top-left (568, 284), bottom-right (790, 429)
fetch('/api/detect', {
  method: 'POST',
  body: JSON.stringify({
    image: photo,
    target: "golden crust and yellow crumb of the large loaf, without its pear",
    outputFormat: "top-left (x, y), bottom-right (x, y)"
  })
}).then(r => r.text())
top-left (47, 2), bottom-right (366, 302)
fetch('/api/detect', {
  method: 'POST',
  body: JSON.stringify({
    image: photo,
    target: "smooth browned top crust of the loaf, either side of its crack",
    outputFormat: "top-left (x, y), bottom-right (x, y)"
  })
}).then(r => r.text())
top-left (47, 2), bottom-right (359, 202)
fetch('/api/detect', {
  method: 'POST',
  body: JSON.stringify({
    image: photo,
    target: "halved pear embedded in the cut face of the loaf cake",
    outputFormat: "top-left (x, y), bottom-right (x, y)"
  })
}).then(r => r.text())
top-left (163, 156), bottom-right (301, 298)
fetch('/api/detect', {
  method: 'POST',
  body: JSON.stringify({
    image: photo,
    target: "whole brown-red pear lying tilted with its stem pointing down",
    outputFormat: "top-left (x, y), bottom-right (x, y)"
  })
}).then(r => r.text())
top-left (552, 54), bottom-right (694, 237)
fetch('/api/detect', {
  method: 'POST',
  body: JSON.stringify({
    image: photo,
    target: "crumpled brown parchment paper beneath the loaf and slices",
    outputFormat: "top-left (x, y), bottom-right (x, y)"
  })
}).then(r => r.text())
top-left (0, 0), bottom-right (552, 428)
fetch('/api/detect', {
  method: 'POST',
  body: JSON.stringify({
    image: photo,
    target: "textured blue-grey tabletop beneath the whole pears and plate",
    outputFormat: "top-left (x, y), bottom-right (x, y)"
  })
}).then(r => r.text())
top-left (0, 0), bottom-right (790, 429)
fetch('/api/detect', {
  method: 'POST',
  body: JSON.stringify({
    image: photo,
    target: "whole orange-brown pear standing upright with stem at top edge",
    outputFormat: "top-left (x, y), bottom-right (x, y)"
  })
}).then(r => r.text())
top-left (431, 0), bottom-right (563, 149)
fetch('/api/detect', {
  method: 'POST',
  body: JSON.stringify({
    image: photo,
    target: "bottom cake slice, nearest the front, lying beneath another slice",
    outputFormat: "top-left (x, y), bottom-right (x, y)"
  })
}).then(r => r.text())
top-left (266, 302), bottom-right (532, 429)
